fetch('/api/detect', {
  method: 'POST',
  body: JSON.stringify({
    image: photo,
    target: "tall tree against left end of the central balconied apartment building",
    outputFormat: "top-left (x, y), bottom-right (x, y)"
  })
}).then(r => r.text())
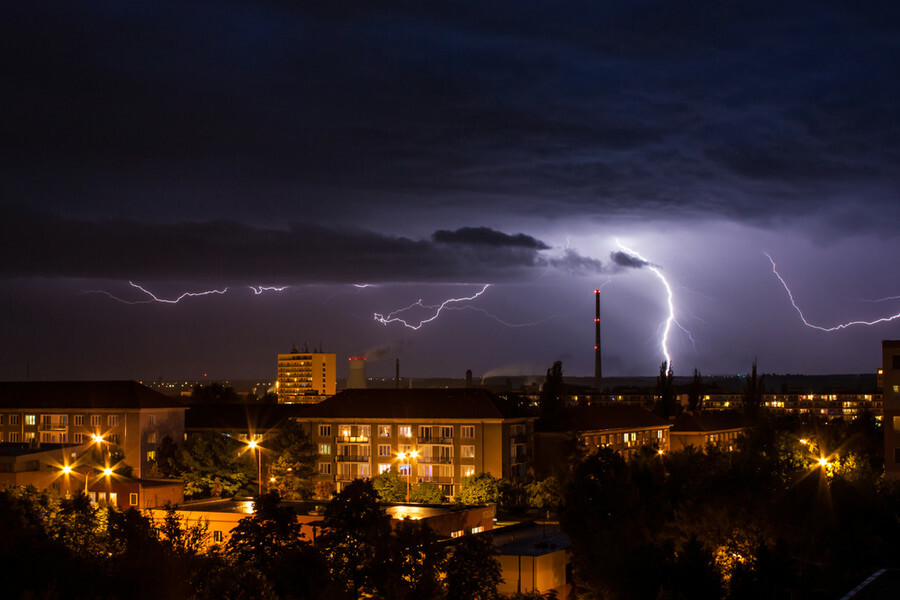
top-left (268, 420), bottom-right (319, 500)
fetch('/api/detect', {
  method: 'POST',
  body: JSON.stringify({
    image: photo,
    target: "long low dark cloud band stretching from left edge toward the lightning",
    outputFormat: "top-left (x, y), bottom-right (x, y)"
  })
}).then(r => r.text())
top-left (0, 208), bottom-right (600, 283)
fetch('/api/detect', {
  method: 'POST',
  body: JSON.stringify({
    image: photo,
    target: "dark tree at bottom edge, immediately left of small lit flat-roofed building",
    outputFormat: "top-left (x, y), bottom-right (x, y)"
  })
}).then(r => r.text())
top-left (445, 534), bottom-right (503, 600)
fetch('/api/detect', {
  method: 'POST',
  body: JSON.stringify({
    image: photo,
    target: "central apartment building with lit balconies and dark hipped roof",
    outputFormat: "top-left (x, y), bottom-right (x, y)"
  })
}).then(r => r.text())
top-left (298, 389), bottom-right (534, 496)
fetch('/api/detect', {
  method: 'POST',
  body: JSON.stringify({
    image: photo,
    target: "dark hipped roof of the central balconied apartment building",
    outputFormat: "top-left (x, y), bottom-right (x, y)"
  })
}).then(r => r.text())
top-left (303, 388), bottom-right (519, 419)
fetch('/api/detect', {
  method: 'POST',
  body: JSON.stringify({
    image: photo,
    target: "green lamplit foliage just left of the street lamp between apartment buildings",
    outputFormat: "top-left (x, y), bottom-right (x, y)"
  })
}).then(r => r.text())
top-left (180, 432), bottom-right (257, 497)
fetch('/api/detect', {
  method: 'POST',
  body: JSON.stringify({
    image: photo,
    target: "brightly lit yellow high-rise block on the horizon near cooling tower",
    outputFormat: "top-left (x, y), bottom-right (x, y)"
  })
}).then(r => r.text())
top-left (275, 347), bottom-right (337, 404)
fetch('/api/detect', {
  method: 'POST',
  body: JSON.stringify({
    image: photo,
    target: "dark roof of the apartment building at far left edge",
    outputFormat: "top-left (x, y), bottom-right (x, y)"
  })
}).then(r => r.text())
top-left (0, 381), bottom-right (186, 409)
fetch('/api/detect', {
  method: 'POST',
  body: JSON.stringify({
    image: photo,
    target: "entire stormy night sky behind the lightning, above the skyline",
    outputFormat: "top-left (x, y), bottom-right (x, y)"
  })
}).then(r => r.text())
top-left (0, 0), bottom-right (900, 379)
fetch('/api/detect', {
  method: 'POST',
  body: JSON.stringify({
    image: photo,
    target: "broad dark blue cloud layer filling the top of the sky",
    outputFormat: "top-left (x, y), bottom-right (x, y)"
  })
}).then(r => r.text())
top-left (0, 0), bottom-right (900, 234)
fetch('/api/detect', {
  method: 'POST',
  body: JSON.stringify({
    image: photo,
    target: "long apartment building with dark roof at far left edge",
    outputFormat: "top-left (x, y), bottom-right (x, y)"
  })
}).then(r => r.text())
top-left (0, 381), bottom-right (187, 478)
